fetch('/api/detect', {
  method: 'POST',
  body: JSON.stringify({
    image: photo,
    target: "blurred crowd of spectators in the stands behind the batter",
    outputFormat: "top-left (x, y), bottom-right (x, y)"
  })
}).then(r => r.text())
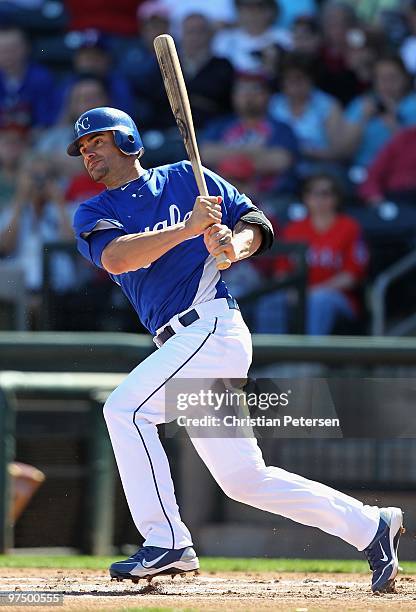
top-left (0, 0), bottom-right (416, 334)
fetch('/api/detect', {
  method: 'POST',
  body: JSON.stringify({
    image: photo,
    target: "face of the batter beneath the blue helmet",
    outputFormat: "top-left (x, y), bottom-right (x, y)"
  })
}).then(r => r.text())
top-left (79, 132), bottom-right (126, 184)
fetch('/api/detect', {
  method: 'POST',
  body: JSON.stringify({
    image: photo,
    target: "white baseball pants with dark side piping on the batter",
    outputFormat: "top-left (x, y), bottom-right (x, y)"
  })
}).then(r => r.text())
top-left (104, 299), bottom-right (380, 550)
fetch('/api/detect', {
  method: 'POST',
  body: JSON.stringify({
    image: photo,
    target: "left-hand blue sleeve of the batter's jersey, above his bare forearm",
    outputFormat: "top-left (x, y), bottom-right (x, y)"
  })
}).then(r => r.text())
top-left (73, 205), bottom-right (127, 268)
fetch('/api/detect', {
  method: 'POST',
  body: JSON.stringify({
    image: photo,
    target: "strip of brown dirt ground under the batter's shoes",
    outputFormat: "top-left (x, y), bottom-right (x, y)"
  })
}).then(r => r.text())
top-left (0, 568), bottom-right (416, 612)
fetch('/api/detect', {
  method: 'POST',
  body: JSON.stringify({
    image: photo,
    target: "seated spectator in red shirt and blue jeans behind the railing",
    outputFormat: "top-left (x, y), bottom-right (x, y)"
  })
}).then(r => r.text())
top-left (254, 174), bottom-right (368, 335)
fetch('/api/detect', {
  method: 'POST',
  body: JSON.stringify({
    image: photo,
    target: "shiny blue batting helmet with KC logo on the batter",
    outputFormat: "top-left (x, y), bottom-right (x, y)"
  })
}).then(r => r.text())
top-left (67, 106), bottom-right (144, 156)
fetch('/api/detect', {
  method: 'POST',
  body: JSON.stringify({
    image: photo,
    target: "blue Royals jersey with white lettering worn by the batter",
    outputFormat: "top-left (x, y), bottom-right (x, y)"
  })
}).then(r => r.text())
top-left (74, 161), bottom-right (255, 334)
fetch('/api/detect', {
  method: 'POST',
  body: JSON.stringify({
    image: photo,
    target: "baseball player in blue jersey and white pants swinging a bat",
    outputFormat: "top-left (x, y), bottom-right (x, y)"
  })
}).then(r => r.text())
top-left (68, 107), bottom-right (402, 591)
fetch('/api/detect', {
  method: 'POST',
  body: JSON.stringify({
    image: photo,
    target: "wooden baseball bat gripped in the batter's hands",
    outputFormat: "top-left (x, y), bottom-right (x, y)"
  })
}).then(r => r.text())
top-left (153, 34), bottom-right (231, 270)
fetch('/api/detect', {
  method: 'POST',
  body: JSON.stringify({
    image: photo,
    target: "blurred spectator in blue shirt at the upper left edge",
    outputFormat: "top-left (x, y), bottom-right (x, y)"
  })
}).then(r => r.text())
top-left (0, 27), bottom-right (56, 128)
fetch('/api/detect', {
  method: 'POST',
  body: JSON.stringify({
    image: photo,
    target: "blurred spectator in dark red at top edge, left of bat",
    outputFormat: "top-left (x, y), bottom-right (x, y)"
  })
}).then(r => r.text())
top-left (65, 0), bottom-right (143, 36)
